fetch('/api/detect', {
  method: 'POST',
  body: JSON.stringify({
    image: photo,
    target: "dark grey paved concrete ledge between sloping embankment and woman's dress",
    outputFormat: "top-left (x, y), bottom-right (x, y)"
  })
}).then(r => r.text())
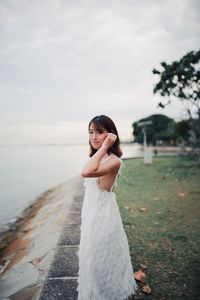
top-left (39, 195), bottom-right (83, 300)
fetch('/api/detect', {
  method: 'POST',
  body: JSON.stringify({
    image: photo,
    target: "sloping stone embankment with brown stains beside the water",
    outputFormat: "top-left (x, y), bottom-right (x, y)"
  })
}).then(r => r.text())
top-left (0, 176), bottom-right (82, 300)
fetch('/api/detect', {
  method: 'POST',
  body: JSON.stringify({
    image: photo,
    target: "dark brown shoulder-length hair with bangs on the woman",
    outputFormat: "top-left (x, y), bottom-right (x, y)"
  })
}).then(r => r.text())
top-left (88, 115), bottom-right (123, 157)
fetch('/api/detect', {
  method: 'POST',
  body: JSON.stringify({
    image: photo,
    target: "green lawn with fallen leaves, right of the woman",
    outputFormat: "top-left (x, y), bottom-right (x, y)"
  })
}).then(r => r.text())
top-left (116, 157), bottom-right (200, 300)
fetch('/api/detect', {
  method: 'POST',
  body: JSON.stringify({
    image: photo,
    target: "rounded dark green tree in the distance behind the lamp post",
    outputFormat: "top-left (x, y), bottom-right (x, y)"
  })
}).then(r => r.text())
top-left (132, 114), bottom-right (177, 145)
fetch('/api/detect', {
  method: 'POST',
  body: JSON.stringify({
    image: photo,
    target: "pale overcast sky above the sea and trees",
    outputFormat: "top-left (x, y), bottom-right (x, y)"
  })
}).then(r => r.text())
top-left (0, 0), bottom-right (200, 145)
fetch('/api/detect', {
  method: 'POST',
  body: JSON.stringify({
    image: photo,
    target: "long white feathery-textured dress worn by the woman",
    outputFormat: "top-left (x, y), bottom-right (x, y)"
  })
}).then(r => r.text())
top-left (77, 157), bottom-right (138, 300)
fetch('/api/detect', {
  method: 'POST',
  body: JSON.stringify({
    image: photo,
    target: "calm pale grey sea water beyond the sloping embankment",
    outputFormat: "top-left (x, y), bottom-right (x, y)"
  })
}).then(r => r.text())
top-left (0, 144), bottom-right (141, 232)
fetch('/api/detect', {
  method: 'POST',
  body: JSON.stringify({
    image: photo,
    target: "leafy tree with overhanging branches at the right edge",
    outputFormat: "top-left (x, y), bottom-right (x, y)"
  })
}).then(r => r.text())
top-left (152, 50), bottom-right (200, 155)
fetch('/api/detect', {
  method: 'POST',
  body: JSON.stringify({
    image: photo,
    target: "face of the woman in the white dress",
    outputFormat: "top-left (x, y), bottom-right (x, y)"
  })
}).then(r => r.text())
top-left (89, 124), bottom-right (108, 149)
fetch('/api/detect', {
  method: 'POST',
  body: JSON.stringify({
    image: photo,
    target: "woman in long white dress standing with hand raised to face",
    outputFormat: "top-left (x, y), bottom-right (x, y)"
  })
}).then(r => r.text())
top-left (77, 115), bottom-right (138, 300)
